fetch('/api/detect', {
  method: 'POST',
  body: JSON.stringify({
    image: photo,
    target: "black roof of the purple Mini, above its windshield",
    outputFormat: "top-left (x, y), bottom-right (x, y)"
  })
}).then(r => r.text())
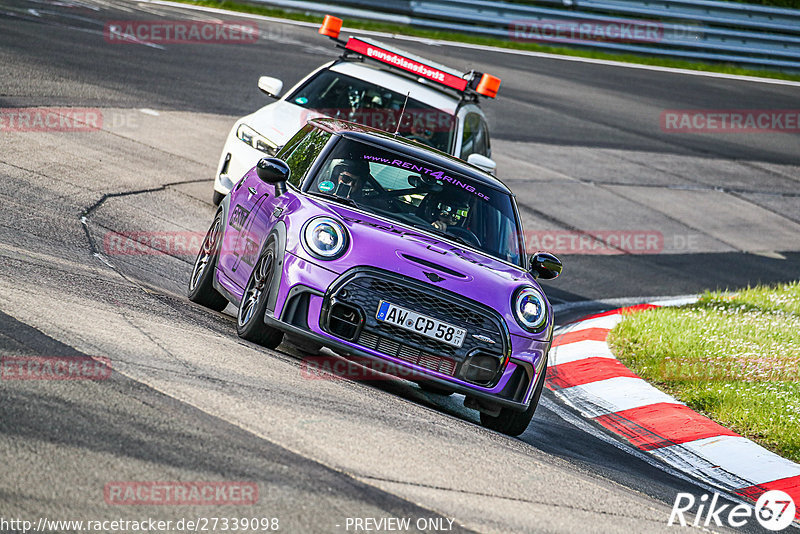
top-left (308, 118), bottom-right (513, 195)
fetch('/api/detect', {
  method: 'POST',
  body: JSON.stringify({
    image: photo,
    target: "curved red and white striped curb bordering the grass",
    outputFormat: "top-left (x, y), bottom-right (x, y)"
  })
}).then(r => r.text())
top-left (546, 304), bottom-right (800, 518)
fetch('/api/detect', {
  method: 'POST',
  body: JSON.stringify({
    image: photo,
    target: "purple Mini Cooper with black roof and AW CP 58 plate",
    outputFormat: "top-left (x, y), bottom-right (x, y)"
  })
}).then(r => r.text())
top-left (189, 119), bottom-right (561, 435)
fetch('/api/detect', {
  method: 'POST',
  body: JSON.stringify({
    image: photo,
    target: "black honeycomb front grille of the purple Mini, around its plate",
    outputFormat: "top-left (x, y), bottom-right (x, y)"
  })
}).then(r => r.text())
top-left (322, 268), bottom-right (509, 385)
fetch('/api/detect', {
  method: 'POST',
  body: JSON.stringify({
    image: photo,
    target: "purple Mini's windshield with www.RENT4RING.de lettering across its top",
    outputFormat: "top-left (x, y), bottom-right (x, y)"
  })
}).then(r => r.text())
top-left (305, 138), bottom-right (522, 265)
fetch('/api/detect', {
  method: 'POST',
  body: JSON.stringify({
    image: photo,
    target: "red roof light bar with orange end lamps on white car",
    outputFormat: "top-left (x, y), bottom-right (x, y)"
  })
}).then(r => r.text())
top-left (319, 15), bottom-right (500, 98)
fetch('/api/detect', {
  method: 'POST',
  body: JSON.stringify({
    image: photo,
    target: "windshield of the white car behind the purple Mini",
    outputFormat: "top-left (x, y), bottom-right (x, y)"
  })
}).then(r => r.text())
top-left (286, 69), bottom-right (455, 152)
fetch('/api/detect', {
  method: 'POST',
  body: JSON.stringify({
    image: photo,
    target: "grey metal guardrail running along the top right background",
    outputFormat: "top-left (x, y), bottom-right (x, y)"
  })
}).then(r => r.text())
top-left (251, 0), bottom-right (800, 70)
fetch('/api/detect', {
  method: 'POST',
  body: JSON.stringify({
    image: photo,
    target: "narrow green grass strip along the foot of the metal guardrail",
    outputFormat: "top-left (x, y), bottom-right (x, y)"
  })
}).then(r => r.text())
top-left (174, 0), bottom-right (800, 81)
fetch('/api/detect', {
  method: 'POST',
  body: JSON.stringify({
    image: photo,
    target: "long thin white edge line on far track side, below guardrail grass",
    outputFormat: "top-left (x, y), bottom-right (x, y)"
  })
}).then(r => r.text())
top-left (139, 0), bottom-right (800, 87)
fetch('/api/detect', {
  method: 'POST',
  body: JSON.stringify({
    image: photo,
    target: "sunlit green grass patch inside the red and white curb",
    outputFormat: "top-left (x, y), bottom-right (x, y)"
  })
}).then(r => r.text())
top-left (609, 282), bottom-right (800, 462)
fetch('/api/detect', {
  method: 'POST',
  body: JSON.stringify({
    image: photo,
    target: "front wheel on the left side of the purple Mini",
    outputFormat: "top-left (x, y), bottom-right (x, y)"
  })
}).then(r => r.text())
top-left (236, 239), bottom-right (283, 349)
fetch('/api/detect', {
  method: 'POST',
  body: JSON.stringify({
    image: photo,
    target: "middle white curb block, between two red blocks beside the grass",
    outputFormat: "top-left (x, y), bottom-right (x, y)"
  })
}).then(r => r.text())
top-left (560, 376), bottom-right (683, 418)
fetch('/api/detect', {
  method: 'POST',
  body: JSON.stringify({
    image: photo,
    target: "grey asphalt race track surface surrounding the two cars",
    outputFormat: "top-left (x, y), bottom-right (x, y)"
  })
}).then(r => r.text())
top-left (0, 0), bottom-right (800, 532)
